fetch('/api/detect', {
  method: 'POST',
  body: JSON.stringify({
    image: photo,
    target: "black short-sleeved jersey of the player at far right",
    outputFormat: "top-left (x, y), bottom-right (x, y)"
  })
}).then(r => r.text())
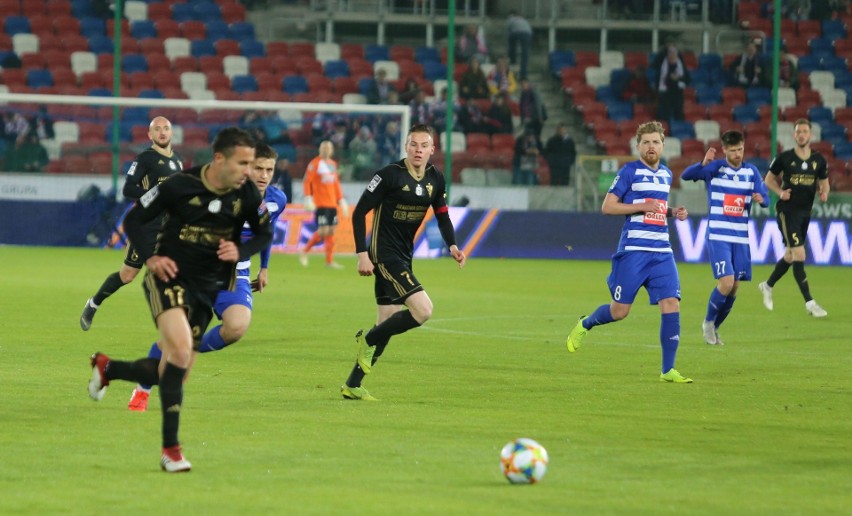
top-left (769, 149), bottom-right (828, 211)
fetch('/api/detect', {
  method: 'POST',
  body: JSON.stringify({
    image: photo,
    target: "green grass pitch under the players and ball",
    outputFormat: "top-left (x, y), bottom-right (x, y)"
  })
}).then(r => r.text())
top-left (0, 247), bottom-right (852, 516)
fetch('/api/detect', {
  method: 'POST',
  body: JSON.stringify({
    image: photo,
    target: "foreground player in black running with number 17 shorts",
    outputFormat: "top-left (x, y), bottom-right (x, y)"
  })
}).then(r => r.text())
top-left (89, 127), bottom-right (272, 472)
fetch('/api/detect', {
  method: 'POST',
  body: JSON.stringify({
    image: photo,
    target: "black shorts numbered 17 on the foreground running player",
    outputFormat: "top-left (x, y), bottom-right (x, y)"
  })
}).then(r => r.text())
top-left (143, 271), bottom-right (218, 349)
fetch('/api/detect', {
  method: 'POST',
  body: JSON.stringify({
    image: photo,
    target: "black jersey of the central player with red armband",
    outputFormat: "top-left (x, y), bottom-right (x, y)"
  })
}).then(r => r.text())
top-left (355, 159), bottom-right (447, 263)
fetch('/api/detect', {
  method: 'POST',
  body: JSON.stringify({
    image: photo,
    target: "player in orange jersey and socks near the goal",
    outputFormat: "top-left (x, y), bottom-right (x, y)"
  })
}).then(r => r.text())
top-left (299, 140), bottom-right (349, 269)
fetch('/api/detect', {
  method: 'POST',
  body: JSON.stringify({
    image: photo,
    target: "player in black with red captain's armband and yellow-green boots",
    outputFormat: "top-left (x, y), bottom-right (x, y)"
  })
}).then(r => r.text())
top-left (340, 125), bottom-right (466, 401)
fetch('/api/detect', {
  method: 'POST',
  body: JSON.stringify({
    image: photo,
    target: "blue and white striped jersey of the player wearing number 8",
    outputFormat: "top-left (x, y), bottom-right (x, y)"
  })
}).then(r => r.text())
top-left (608, 160), bottom-right (673, 253)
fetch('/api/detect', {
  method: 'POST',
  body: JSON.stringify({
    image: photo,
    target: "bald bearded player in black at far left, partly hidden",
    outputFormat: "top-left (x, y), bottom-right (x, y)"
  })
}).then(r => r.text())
top-left (80, 116), bottom-right (183, 331)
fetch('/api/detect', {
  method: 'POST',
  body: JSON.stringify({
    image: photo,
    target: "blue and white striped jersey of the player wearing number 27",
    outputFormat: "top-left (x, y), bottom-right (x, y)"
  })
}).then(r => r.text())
top-left (681, 159), bottom-right (769, 245)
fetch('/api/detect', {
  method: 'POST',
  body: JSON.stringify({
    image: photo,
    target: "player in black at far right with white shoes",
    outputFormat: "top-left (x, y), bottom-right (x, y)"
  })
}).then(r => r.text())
top-left (758, 118), bottom-right (830, 317)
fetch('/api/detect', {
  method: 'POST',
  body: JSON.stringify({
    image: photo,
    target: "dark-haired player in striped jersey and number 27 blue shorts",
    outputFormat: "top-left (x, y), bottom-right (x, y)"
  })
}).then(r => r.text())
top-left (681, 131), bottom-right (769, 346)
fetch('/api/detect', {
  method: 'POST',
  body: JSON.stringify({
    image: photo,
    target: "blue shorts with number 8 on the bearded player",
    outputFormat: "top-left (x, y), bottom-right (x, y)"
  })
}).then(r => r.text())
top-left (606, 251), bottom-right (680, 305)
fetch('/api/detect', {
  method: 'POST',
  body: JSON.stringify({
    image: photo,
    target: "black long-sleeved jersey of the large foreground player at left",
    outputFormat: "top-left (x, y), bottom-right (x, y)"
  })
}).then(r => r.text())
top-left (125, 165), bottom-right (272, 290)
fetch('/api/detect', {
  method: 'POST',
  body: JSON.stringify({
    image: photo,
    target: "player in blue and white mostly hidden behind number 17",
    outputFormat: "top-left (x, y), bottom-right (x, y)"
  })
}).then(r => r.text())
top-left (127, 142), bottom-right (287, 412)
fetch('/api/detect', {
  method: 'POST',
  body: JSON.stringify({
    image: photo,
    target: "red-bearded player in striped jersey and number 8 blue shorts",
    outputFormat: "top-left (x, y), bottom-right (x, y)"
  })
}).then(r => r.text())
top-left (567, 122), bottom-right (692, 383)
